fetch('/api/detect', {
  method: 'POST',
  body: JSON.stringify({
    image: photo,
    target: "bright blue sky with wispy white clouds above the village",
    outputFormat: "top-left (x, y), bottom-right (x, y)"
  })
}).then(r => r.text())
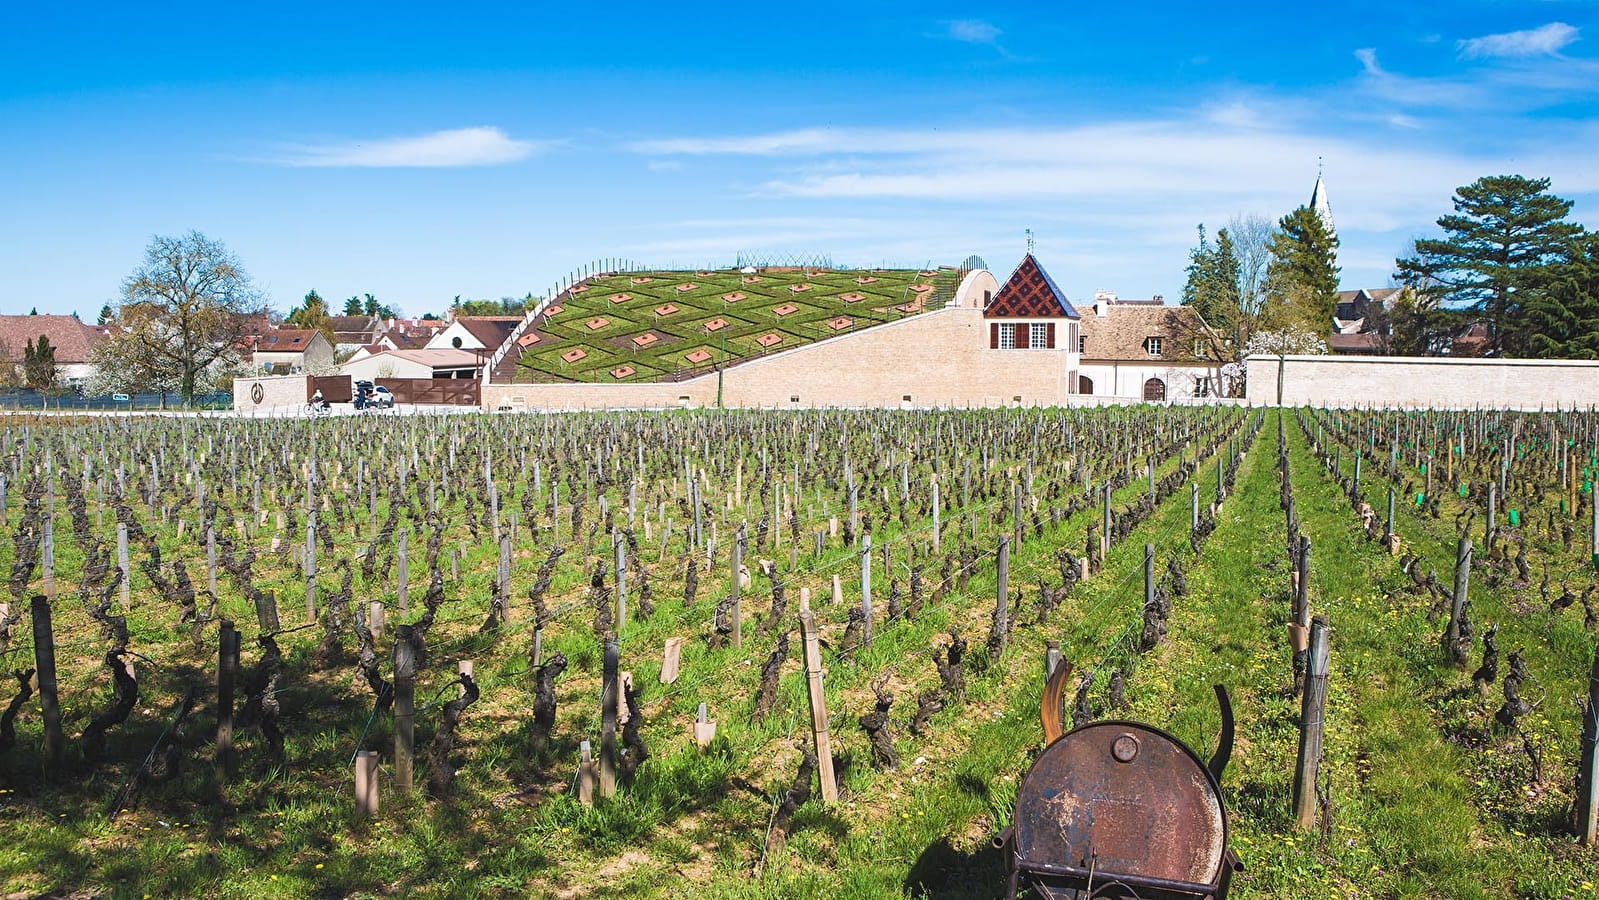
top-left (0, 0), bottom-right (1599, 318)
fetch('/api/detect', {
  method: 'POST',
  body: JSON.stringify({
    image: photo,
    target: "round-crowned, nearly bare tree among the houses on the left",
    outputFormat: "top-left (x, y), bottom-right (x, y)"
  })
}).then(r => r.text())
top-left (96, 232), bottom-right (262, 403)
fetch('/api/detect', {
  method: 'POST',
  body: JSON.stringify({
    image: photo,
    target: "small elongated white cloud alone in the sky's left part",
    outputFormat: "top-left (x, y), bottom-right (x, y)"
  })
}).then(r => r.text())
top-left (264, 126), bottom-right (550, 168)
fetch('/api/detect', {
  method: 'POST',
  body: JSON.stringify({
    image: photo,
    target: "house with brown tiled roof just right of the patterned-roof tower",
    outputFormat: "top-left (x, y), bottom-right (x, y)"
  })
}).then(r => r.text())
top-left (1078, 291), bottom-right (1220, 401)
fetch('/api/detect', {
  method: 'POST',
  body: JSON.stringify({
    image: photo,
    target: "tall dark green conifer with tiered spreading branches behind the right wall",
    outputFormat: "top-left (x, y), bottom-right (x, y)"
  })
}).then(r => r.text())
top-left (1396, 174), bottom-right (1583, 356)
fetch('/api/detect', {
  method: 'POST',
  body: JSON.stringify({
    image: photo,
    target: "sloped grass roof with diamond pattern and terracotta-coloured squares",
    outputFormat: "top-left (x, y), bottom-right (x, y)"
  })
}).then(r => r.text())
top-left (515, 269), bottom-right (963, 384)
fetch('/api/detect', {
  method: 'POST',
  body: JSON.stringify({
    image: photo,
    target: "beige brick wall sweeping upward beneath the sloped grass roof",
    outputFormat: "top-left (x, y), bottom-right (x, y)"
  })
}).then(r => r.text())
top-left (484, 309), bottom-right (1076, 409)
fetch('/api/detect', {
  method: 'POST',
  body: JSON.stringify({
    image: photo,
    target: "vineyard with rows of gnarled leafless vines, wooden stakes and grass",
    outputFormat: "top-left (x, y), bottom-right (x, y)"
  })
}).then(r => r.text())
top-left (0, 409), bottom-right (1599, 900)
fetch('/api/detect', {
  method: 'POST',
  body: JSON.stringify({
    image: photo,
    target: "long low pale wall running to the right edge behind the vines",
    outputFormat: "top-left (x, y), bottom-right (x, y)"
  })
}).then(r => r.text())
top-left (1249, 356), bottom-right (1599, 409)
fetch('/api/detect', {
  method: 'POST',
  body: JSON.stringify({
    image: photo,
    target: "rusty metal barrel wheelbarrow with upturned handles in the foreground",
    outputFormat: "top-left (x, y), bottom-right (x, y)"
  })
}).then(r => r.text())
top-left (995, 662), bottom-right (1242, 900)
